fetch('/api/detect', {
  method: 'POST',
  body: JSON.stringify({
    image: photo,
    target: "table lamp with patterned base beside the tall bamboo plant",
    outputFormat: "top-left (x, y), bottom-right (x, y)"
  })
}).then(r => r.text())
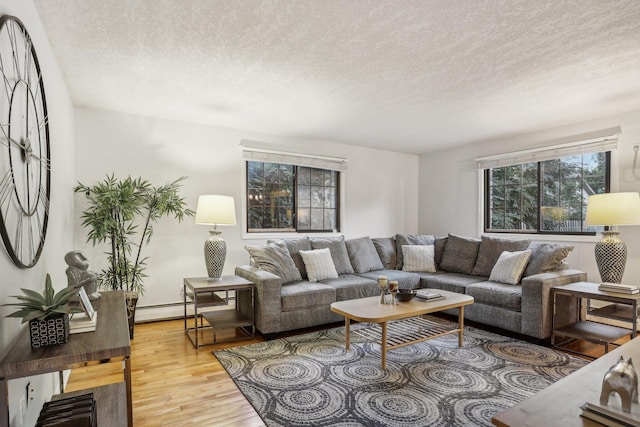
top-left (196, 195), bottom-right (236, 280)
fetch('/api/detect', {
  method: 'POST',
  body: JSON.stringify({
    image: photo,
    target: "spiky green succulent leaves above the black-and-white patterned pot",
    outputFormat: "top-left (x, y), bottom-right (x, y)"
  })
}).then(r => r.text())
top-left (3, 274), bottom-right (82, 323)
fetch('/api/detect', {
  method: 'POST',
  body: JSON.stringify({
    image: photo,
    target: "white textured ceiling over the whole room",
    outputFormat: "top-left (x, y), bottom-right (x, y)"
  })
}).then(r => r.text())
top-left (34, 0), bottom-right (640, 153)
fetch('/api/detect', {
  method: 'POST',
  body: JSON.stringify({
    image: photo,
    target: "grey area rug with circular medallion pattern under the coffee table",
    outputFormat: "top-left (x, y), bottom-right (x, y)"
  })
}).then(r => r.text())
top-left (213, 319), bottom-right (588, 427)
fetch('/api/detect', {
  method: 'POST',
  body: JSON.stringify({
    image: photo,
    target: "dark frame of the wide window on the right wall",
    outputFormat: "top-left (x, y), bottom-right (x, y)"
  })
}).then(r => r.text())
top-left (480, 149), bottom-right (615, 237)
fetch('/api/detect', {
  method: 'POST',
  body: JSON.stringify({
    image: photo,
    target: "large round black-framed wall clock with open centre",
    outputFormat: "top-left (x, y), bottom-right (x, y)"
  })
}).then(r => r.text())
top-left (0, 15), bottom-right (51, 268)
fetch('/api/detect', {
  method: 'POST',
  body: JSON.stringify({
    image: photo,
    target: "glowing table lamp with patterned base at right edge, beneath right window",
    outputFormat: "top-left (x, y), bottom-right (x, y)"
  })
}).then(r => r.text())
top-left (585, 193), bottom-right (640, 283)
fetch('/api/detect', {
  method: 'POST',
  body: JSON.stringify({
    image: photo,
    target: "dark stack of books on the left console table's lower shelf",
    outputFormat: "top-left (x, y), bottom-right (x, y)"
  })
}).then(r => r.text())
top-left (36, 393), bottom-right (97, 427)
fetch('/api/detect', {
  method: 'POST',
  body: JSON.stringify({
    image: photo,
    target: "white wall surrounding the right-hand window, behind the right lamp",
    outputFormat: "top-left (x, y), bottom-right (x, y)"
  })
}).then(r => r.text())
top-left (419, 111), bottom-right (640, 284)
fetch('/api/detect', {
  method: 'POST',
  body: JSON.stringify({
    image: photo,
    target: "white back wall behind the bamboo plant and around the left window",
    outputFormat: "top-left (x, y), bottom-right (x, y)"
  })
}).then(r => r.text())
top-left (74, 109), bottom-right (418, 320)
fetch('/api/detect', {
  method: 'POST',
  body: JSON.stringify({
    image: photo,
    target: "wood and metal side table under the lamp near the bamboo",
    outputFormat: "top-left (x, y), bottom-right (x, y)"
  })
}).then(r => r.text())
top-left (183, 275), bottom-right (255, 348)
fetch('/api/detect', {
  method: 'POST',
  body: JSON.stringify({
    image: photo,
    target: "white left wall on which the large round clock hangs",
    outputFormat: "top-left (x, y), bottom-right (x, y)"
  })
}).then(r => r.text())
top-left (0, 0), bottom-right (74, 426)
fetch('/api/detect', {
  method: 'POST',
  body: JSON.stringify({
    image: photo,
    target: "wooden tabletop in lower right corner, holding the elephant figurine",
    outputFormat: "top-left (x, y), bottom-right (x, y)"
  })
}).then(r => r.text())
top-left (491, 337), bottom-right (640, 427)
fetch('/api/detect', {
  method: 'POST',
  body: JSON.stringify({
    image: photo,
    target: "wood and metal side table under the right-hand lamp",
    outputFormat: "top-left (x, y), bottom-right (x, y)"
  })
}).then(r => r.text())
top-left (551, 282), bottom-right (640, 353)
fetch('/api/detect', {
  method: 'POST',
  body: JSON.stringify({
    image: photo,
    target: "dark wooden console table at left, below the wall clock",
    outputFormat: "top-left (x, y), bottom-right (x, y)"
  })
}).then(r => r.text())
top-left (0, 291), bottom-right (133, 427)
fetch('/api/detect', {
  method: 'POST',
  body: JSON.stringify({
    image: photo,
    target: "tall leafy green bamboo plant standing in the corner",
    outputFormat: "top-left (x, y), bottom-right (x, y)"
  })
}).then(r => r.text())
top-left (74, 175), bottom-right (194, 338)
